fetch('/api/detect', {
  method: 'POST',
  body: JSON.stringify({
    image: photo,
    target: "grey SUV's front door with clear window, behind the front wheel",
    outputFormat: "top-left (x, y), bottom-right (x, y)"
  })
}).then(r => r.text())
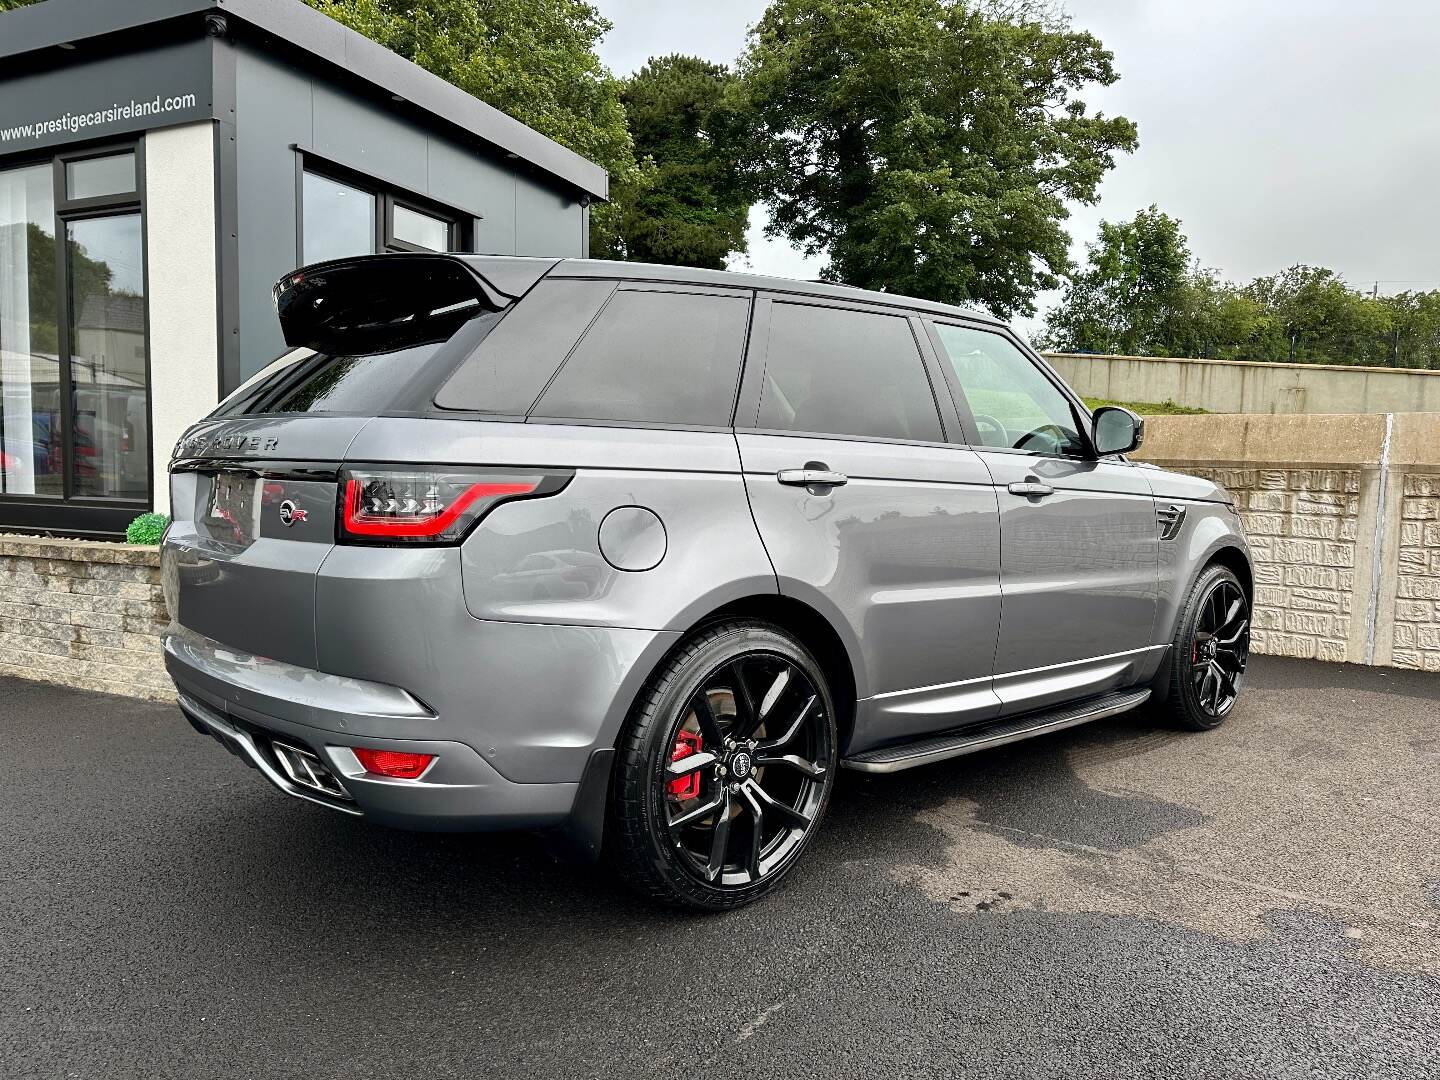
top-left (926, 320), bottom-right (1159, 714)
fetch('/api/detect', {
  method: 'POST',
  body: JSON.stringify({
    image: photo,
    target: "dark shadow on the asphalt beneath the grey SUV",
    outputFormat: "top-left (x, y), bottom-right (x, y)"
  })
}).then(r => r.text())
top-left (212, 705), bottom-right (1205, 940)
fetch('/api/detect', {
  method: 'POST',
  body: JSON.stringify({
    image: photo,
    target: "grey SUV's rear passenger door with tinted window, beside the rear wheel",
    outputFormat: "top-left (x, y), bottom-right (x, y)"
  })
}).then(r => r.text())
top-left (736, 297), bottom-right (999, 752)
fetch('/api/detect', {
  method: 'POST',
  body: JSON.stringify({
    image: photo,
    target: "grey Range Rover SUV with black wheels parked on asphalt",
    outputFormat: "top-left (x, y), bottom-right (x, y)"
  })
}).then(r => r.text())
top-left (163, 255), bottom-right (1251, 909)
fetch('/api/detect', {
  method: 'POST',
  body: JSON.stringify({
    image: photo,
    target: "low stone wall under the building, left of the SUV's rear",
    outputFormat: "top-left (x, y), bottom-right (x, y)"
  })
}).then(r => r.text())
top-left (0, 536), bottom-right (174, 700)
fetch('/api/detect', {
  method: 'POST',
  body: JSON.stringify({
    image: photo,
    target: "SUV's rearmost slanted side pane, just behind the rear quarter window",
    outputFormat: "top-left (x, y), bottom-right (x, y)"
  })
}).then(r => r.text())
top-left (435, 278), bottom-right (615, 416)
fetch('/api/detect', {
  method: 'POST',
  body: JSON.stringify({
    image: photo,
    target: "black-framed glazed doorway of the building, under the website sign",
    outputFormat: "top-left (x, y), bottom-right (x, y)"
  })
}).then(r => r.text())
top-left (0, 145), bottom-right (151, 534)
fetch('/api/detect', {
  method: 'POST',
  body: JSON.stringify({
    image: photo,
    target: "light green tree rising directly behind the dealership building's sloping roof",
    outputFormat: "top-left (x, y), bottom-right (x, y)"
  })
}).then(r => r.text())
top-left (305, 0), bottom-right (644, 255)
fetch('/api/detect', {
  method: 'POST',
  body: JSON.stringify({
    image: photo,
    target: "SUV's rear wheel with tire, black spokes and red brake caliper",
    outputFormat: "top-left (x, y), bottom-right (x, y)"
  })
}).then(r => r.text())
top-left (606, 619), bottom-right (838, 912)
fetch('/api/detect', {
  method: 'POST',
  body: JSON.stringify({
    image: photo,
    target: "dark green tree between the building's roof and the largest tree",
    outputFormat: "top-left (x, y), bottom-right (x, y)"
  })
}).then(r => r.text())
top-left (619, 56), bottom-right (750, 269)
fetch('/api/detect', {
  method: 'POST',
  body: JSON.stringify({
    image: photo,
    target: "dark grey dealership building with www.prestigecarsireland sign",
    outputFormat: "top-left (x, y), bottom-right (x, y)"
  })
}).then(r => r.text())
top-left (0, 0), bottom-right (608, 536)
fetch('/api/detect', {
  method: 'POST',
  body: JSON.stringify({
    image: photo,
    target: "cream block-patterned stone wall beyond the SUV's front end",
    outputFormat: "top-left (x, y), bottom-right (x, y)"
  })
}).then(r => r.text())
top-left (1138, 413), bottom-right (1440, 671)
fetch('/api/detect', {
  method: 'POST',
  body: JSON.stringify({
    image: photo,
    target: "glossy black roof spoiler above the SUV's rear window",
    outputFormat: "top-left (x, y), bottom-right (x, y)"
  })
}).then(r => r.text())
top-left (274, 253), bottom-right (559, 353)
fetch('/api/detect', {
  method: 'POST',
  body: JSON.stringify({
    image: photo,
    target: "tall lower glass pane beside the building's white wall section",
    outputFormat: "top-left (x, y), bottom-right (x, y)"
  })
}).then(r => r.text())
top-left (66, 213), bottom-right (150, 500)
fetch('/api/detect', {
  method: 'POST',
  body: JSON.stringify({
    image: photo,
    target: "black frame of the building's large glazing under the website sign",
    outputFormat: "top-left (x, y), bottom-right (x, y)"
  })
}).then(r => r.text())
top-left (0, 135), bottom-right (156, 537)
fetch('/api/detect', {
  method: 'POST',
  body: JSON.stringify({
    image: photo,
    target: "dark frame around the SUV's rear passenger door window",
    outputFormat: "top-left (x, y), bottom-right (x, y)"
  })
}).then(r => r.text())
top-left (733, 292), bottom-right (960, 448)
